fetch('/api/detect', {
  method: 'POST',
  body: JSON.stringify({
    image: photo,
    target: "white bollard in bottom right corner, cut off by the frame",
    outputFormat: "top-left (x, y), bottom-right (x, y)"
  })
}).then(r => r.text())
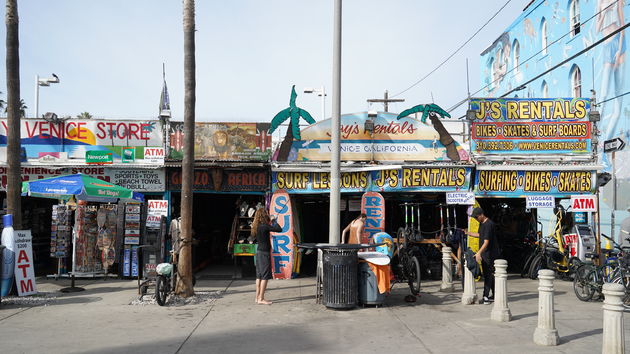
top-left (602, 283), bottom-right (626, 354)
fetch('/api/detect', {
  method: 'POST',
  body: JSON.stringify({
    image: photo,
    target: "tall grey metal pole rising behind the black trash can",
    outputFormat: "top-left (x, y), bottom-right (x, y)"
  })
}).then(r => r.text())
top-left (328, 0), bottom-right (341, 243)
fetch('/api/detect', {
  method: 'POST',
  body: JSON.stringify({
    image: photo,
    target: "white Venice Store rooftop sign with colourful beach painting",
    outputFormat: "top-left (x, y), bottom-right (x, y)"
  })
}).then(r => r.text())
top-left (0, 119), bottom-right (163, 160)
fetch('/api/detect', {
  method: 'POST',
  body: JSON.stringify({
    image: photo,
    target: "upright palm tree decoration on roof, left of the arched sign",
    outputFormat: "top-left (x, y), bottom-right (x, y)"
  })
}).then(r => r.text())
top-left (269, 85), bottom-right (315, 161)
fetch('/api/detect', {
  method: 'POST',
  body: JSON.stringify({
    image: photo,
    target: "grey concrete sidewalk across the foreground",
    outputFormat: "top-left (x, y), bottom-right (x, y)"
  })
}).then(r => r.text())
top-left (0, 277), bottom-right (630, 353)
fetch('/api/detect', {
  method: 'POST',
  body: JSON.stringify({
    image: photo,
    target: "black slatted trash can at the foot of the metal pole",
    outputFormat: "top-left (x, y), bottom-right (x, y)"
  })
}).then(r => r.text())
top-left (323, 248), bottom-right (359, 309)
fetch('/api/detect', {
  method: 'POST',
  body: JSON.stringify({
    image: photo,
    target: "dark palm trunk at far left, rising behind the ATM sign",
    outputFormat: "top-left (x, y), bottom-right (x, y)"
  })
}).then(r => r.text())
top-left (6, 0), bottom-right (22, 230)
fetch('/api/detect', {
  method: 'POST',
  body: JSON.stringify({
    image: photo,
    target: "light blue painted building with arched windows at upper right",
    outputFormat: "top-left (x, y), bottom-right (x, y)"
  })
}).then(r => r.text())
top-left (478, 0), bottom-right (630, 241)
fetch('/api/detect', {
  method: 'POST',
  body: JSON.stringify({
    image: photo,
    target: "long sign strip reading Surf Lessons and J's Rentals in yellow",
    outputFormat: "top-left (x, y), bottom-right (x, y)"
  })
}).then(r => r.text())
top-left (272, 167), bottom-right (471, 193)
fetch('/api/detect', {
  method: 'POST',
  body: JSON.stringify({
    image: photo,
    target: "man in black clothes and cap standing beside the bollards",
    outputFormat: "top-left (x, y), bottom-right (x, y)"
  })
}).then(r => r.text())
top-left (468, 208), bottom-right (499, 305)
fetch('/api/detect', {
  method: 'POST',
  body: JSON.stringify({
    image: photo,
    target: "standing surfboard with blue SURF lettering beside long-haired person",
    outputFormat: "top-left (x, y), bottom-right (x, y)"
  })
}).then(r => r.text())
top-left (269, 189), bottom-right (296, 279)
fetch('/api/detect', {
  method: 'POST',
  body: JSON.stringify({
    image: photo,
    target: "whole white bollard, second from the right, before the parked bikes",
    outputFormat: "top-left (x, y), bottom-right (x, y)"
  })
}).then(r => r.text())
top-left (534, 269), bottom-right (560, 345)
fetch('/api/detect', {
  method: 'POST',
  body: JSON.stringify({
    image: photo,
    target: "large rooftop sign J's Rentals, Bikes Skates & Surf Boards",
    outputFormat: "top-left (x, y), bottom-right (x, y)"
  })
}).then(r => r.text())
top-left (470, 98), bottom-right (591, 154)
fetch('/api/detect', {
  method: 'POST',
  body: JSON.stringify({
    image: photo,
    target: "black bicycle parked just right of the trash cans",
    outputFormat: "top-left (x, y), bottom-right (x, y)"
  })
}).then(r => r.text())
top-left (390, 227), bottom-right (420, 296)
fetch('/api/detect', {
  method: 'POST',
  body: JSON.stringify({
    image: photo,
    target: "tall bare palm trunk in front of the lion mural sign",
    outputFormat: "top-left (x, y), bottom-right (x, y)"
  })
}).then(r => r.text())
top-left (175, 0), bottom-right (195, 297)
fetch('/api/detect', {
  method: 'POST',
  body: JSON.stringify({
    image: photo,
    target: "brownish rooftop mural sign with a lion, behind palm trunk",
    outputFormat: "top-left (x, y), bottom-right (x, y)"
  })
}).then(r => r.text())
top-left (169, 122), bottom-right (271, 161)
